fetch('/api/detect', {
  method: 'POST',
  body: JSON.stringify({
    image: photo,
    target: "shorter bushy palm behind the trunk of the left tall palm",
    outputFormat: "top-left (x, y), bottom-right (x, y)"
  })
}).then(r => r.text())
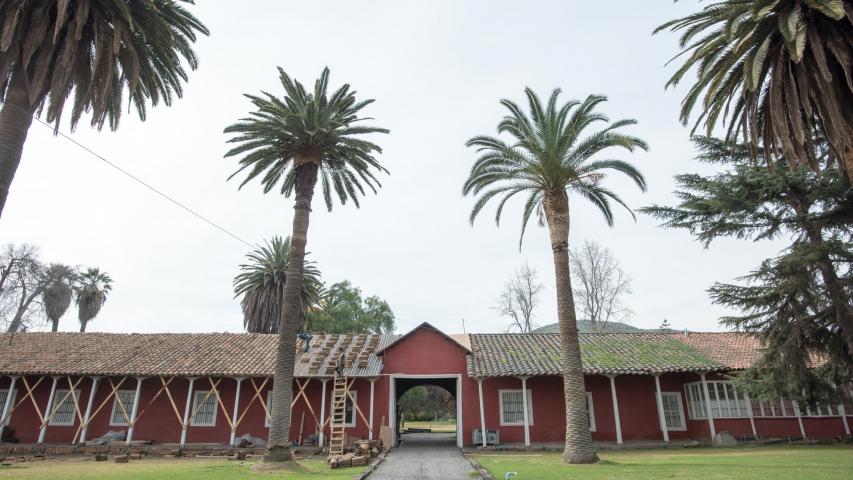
top-left (234, 236), bottom-right (323, 333)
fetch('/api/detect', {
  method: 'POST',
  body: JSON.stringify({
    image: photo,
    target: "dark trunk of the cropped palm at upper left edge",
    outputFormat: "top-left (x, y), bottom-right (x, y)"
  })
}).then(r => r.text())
top-left (0, 69), bottom-right (34, 217)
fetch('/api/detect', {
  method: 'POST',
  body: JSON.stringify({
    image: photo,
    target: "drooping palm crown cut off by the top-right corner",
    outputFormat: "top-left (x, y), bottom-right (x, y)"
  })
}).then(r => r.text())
top-left (655, 0), bottom-right (853, 180)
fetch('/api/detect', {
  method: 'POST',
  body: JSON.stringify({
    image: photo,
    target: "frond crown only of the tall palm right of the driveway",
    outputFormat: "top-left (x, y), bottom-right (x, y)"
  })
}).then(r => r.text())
top-left (462, 88), bottom-right (648, 247)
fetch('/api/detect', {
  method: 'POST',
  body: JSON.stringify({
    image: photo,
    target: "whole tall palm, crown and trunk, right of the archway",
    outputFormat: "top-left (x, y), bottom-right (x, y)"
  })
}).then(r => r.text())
top-left (462, 88), bottom-right (648, 463)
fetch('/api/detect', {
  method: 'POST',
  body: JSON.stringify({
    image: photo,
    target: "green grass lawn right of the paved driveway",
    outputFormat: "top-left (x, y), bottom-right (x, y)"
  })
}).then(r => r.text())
top-left (474, 445), bottom-right (853, 480)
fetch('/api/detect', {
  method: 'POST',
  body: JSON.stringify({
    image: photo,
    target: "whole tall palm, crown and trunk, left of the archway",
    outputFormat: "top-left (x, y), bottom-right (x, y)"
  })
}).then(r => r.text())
top-left (225, 68), bottom-right (388, 462)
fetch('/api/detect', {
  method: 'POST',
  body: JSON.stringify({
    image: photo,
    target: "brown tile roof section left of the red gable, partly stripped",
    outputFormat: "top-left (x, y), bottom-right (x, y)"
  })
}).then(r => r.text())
top-left (0, 332), bottom-right (396, 377)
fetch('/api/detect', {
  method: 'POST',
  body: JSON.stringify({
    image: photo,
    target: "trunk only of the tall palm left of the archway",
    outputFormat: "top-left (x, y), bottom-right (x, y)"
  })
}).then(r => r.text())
top-left (264, 159), bottom-right (317, 462)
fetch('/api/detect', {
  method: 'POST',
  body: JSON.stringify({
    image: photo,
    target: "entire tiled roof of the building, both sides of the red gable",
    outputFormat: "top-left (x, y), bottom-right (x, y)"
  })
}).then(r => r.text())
top-left (0, 327), bottom-right (759, 377)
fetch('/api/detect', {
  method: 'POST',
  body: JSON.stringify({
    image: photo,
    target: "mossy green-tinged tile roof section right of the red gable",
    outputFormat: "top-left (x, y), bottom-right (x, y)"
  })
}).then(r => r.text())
top-left (468, 333), bottom-right (744, 377)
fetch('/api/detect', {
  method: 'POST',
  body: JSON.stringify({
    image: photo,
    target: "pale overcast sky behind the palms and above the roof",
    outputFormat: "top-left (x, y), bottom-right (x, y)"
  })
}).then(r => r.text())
top-left (0, 0), bottom-right (778, 332)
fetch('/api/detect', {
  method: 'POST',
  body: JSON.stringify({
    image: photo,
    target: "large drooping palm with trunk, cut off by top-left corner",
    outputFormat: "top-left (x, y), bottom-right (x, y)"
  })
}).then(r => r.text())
top-left (0, 0), bottom-right (208, 215)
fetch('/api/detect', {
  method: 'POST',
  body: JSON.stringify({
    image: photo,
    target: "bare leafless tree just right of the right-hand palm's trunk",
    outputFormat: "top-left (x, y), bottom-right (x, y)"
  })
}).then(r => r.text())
top-left (569, 241), bottom-right (633, 331)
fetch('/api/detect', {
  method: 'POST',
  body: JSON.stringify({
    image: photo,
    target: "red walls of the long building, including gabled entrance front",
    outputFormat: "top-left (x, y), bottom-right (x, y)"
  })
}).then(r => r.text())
top-left (0, 334), bottom-right (853, 445)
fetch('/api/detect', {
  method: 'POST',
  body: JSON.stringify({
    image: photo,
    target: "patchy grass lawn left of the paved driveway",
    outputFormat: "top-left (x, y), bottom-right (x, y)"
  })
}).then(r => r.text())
top-left (0, 458), bottom-right (352, 480)
